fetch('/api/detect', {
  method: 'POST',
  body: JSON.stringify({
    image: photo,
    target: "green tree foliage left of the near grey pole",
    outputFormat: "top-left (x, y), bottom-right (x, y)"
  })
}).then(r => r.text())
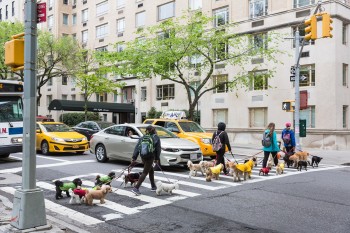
top-left (0, 21), bottom-right (24, 79)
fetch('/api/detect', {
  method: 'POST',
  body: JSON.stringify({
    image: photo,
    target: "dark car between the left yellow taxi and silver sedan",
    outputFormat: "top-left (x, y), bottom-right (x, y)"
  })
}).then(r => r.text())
top-left (72, 121), bottom-right (115, 141)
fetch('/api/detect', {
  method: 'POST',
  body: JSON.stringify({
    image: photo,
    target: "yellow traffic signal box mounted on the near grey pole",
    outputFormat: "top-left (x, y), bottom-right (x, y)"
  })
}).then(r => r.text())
top-left (5, 33), bottom-right (24, 70)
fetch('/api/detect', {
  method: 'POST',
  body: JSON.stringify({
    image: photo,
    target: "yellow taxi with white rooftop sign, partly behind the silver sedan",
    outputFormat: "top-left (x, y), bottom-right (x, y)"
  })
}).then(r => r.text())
top-left (143, 111), bottom-right (216, 157)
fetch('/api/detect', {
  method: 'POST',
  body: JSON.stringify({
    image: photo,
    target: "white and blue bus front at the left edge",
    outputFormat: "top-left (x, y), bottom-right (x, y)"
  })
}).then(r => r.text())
top-left (0, 80), bottom-right (23, 158)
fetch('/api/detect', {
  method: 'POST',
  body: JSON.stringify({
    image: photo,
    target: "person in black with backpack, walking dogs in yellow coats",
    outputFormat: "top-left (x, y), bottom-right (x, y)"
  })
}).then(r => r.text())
top-left (211, 122), bottom-right (231, 175)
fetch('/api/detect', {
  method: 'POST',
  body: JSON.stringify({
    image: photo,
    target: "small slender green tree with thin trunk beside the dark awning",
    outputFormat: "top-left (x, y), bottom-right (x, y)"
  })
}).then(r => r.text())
top-left (72, 49), bottom-right (124, 121)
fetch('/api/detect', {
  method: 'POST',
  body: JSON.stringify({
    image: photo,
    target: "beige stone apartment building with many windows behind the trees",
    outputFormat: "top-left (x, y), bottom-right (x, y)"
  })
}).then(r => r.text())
top-left (3, 0), bottom-right (350, 149)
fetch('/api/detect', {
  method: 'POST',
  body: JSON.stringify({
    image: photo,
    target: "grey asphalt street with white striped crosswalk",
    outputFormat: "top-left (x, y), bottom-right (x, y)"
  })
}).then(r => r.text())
top-left (0, 150), bottom-right (350, 233)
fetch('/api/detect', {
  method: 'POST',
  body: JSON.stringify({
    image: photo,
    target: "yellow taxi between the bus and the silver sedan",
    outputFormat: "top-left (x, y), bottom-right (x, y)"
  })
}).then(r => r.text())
top-left (36, 119), bottom-right (89, 155)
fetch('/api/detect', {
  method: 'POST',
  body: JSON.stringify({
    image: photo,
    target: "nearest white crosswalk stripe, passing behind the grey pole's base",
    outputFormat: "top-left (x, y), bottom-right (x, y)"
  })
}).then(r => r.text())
top-left (1, 186), bottom-right (103, 225)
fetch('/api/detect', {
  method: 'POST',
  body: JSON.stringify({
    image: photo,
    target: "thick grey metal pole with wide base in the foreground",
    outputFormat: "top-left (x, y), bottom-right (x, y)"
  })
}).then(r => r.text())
top-left (11, 0), bottom-right (47, 229)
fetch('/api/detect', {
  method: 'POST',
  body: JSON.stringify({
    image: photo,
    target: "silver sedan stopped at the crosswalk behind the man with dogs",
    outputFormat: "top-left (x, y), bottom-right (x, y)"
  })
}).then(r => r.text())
top-left (90, 124), bottom-right (203, 166)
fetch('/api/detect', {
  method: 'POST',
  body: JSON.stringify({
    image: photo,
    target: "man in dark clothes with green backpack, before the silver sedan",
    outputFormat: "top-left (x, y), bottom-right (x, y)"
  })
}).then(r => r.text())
top-left (131, 125), bottom-right (161, 195)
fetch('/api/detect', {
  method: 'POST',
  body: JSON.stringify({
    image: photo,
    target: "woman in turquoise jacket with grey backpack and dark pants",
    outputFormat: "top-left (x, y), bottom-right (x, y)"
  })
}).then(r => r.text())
top-left (262, 122), bottom-right (280, 168)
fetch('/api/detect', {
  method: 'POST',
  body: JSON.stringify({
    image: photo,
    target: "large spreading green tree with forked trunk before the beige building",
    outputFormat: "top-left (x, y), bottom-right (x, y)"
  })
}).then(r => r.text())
top-left (99, 13), bottom-right (280, 119)
